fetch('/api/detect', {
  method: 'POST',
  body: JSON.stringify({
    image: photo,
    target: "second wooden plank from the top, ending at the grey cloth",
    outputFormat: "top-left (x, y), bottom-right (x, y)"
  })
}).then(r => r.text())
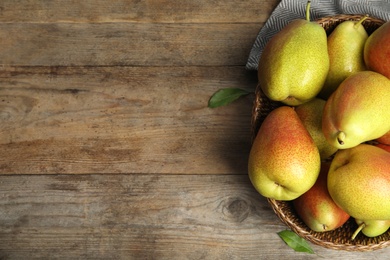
top-left (0, 23), bottom-right (262, 66)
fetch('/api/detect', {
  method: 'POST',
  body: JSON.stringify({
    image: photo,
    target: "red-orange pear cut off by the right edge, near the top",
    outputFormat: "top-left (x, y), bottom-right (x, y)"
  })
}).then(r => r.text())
top-left (364, 21), bottom-right (390, 79)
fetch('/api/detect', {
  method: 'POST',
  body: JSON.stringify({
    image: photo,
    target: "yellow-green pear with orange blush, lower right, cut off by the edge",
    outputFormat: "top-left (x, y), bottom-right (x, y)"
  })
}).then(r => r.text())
top-left (328, 144), bottom-right (390, 220)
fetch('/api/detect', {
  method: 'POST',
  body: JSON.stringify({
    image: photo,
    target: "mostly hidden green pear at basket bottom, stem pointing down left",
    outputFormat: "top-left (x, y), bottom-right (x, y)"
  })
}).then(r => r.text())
top-left (352, 219), bottom-right (390, 240)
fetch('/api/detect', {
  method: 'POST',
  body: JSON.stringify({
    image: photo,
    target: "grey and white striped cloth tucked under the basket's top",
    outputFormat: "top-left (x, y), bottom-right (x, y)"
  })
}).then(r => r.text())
top-left (246, 0), bottom-right (390, 70)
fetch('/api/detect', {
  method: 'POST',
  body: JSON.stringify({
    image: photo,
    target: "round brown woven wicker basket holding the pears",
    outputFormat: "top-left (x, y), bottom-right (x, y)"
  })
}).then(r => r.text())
top-left (251, 15), bottom-right (390, 251)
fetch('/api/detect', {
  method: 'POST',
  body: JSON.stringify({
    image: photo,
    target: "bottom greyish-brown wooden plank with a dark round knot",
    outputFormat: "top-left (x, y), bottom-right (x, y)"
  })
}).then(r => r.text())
top-left (0, 175), bottom-right (390, 259)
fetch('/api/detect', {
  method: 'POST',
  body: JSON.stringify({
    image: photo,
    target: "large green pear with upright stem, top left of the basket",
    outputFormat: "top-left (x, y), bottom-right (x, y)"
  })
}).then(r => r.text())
top-left (258, 2), bottom-right (329, 106)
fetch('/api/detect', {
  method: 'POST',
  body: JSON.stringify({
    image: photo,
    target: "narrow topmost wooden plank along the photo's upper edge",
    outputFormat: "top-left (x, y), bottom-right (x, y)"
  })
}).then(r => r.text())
top-left (0, 0), bottom-right (279, 23)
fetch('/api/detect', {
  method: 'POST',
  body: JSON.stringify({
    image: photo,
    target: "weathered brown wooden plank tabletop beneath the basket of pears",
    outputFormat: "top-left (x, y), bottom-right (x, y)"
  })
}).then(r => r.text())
top-left (0, 0), bottom-right (390, 259)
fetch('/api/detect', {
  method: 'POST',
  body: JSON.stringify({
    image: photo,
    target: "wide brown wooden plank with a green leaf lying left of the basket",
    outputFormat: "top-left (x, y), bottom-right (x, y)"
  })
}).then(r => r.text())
top-left (0, 67), bottom-right (257, 174)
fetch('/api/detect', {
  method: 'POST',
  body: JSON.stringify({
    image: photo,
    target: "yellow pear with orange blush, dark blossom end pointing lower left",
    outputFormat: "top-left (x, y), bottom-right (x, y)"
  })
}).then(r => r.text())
top-left (322, 71), bottom-right (390, 149)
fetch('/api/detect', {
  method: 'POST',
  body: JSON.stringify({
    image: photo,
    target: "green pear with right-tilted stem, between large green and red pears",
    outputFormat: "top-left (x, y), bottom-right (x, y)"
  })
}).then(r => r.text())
top-left (318, 16), bottom-right (368, 99)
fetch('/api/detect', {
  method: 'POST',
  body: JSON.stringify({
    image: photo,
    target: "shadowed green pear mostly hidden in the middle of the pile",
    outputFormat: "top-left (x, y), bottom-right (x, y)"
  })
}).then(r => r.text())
top-left (295, 98), bottom-right (337, 159)
